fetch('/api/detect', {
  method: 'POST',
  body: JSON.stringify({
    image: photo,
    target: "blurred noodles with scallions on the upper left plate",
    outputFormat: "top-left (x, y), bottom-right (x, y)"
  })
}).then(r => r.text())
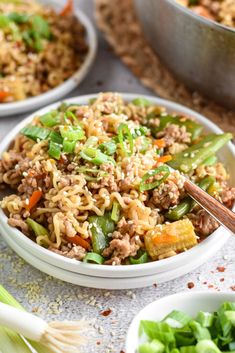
top-left (0, 0), bottom-right (87, 103)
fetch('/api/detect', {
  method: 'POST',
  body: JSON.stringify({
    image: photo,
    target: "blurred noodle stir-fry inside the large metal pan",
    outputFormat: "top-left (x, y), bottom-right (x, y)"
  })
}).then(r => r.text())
top-left (176, 0), bottom-right (235, 27)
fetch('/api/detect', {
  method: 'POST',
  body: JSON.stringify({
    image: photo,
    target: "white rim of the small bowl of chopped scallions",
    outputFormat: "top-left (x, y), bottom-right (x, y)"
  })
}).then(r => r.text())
top-left (125, 290), bottom-right (235, 353)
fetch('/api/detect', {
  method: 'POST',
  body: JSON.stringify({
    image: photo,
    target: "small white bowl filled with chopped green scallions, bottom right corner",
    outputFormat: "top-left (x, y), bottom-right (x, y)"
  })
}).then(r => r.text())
top-left (126, 292), bottom-right (235, 353)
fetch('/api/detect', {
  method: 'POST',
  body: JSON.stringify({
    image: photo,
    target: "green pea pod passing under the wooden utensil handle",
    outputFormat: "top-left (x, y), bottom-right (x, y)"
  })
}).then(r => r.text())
top-left (165, 176), bottom-right (215, 221)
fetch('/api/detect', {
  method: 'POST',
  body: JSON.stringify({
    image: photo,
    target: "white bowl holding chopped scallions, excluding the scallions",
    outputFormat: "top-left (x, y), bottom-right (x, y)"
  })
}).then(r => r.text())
top-left (125, 292), bottom-right (235, 353)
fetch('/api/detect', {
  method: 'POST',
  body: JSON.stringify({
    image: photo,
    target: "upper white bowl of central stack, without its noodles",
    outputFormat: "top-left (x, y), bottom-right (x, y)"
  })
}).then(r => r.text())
top-left (0, 93), bottom-right (235, 281)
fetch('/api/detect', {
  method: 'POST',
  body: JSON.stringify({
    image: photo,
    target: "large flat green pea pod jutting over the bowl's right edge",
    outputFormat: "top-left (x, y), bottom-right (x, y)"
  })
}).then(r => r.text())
top-left (168, 133), bottom-right (233, 173)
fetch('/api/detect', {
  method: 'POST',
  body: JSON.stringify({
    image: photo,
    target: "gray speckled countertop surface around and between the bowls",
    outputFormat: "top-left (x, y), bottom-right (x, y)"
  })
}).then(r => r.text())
top-left (0, 0), bottom-right (235, 353)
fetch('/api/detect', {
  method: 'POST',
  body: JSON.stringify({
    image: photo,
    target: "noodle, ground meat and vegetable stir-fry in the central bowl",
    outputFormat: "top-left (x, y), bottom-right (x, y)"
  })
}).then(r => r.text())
top-left (0, 93), bottom-right (235, 265)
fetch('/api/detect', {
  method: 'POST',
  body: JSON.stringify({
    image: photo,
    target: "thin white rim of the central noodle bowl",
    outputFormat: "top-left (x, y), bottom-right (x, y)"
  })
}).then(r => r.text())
top-left (0, 92), bottom-right (235, 277)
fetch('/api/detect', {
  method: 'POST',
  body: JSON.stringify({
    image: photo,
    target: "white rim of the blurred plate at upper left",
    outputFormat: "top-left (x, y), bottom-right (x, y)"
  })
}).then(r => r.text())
top-left (0, 0), bottom-right (97, 117)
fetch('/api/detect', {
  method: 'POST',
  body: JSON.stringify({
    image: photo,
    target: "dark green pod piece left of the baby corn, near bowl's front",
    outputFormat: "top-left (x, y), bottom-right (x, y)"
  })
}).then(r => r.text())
top-left (88, 213), bottom-right (115, 254)
